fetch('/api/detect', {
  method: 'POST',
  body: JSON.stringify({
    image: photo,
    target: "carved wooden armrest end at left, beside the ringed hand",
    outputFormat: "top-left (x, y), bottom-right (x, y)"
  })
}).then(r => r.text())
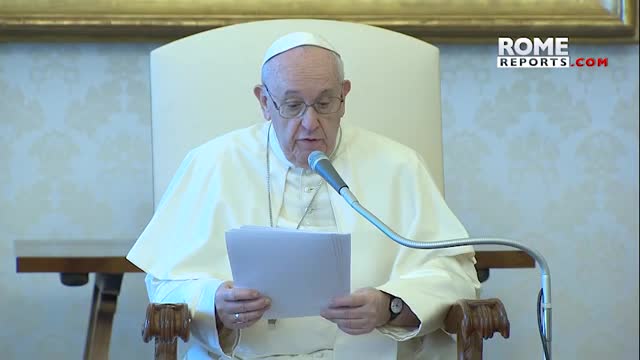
top-left (142, 304), bottom-right (191, 360)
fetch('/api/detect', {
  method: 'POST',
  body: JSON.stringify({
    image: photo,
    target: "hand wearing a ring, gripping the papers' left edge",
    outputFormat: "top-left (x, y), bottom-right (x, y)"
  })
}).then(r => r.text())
top-left (215, 281), bottom-right (271, 329)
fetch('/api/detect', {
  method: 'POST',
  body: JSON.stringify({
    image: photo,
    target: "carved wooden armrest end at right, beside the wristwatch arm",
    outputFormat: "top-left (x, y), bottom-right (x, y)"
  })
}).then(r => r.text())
top-left (444, 299), bottom-right (509, 360)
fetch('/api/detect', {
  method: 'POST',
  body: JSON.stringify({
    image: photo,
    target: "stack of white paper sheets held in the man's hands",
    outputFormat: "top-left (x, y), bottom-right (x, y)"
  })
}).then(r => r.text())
top-left (225, 226), bottom-right (351, 319)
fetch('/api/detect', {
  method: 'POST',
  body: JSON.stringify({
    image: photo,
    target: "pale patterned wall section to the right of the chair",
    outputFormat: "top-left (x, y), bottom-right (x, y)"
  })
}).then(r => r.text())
top-left (442, 46), bottom-right (638, 360)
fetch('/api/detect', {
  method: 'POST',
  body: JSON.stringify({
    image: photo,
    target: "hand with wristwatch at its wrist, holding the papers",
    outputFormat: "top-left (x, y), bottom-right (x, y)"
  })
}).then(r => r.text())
top-left (320, 288), bottom-right (391, 335)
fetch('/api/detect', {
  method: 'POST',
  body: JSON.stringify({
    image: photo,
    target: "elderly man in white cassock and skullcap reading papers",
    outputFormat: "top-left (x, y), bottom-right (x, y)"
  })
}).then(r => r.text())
top-left (127, 33), bottom-right (479, 360)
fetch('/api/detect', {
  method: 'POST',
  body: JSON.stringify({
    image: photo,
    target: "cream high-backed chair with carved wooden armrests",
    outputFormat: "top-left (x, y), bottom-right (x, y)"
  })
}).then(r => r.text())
top-left (143, 20), bottom-right (509, 359)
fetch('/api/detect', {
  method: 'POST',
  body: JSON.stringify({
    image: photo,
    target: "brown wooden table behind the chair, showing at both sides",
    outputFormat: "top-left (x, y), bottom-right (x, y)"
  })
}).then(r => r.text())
top-left (15, 240), bottom-right (535, 360)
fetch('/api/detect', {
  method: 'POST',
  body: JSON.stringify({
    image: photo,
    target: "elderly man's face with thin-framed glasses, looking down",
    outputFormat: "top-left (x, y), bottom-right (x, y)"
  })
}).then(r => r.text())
top-left (254, 46), bottom-right (351, 168)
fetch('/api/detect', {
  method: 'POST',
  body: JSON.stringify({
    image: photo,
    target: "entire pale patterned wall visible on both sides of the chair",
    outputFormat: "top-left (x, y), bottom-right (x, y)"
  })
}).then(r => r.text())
top-left (0, 44), bottom-right (639, 360)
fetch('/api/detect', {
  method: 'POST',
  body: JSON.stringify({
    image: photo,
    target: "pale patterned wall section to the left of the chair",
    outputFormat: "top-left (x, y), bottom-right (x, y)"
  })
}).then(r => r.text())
top-left (0, 44), bottom-right (154, 359)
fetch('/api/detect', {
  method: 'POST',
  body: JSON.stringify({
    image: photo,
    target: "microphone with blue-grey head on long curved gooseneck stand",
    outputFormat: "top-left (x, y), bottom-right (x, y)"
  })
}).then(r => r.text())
top-left (308, 151), bottom-right (551, 360)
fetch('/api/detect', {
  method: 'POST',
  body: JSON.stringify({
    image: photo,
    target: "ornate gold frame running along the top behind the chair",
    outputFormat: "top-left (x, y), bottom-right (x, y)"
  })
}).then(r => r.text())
top-left (0, 0), bottom-right (638, 43)
